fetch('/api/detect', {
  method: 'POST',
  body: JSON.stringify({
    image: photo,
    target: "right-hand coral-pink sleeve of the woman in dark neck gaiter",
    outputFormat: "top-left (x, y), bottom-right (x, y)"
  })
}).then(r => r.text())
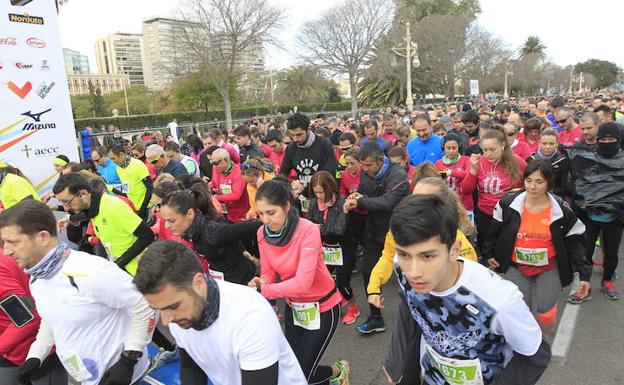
top-left (260, 226), bottom-right (321, 299)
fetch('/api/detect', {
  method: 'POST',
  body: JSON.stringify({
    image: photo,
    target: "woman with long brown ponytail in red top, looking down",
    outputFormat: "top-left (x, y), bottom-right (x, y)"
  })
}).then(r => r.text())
top-left (462, 124), bottom-right (527, 252)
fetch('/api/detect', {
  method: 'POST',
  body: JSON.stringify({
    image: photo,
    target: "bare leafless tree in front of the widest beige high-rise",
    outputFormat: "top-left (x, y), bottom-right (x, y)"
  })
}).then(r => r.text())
top-left (176, 0), bottom-right (285, 128)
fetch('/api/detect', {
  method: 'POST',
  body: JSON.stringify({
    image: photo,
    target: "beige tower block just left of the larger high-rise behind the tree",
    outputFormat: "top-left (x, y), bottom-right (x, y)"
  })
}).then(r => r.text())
top-left (95, 33), bottom-right (145, 84)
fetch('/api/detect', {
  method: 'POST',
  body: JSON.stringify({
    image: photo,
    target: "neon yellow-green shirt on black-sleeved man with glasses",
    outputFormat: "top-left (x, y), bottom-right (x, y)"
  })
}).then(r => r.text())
top-left (91, 194), bottom-right (141, 275)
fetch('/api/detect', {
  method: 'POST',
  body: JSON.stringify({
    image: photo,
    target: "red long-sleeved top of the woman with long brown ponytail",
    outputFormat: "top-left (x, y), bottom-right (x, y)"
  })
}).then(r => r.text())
top-left (462, 156), bottom-right (526, 215)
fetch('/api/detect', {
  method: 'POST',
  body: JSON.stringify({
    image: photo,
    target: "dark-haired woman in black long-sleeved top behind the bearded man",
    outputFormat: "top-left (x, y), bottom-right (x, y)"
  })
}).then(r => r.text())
top-left (160, 182), bottom-right (261, 284)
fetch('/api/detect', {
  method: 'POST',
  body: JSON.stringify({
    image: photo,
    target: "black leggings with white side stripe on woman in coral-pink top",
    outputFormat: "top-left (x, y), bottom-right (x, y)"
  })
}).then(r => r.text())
top-left (284, 304), bottom-right (341, 384)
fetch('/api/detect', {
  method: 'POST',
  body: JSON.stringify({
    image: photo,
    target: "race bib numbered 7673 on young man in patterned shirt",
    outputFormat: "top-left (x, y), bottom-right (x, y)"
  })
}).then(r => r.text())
top-left (426, 345), bottom-right (483, 385)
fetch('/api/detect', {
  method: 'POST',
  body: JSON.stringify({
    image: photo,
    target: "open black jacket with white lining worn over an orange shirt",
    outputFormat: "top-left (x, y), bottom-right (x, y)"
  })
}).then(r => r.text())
top-left (483, 192), bottom-right (592, 286)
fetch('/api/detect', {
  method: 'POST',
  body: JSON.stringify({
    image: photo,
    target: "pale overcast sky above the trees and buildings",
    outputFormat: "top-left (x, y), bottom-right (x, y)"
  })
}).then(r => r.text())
top-left (60, 0), bottom-right (624, 72)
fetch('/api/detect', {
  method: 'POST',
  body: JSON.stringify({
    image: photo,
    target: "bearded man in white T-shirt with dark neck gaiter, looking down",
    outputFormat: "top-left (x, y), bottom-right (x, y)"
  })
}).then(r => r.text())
top-left (134, 241), bottom-right (308, 385)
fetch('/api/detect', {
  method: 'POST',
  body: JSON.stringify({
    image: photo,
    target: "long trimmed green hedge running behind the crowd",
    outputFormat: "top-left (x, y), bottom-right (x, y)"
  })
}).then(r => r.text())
top-left (74, 101), bottom-right (351, 131)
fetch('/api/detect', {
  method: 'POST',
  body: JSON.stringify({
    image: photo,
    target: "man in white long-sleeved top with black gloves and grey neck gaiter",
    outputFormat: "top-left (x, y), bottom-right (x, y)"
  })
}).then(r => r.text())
top-left (0, 200), bottom-right (156, 385)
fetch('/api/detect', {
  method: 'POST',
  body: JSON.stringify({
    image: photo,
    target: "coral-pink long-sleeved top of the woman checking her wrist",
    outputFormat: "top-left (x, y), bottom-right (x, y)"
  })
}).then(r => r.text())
top-left (258, 218), bottom-right (343, 312)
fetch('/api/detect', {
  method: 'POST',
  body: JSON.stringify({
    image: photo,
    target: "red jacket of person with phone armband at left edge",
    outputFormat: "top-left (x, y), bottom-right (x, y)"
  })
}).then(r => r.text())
top-left (0, 249), bottom-right (41, 365)
